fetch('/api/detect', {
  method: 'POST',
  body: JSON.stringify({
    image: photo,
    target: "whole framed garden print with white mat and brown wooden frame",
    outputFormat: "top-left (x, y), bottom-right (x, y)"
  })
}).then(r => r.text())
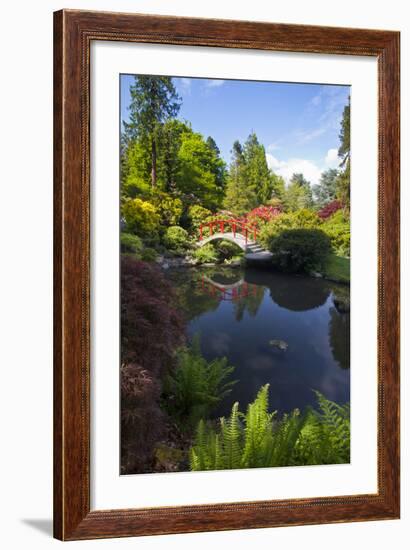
top-left (54, 10), bottom-right (400, 540)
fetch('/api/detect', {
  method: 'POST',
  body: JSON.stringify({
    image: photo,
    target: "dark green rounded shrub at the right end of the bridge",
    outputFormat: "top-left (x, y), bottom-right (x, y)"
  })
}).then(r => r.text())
top-left (269, 229), bottom-right (331, 273)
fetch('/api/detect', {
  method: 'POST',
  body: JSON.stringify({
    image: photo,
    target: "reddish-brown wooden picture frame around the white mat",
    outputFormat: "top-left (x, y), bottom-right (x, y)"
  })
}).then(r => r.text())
top-left (54, 10), bottom-right (400, 540)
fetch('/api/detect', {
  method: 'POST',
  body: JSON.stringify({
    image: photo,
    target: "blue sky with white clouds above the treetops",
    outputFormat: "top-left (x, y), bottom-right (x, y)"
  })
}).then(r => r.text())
top-left (121, 75), bottom-right (350, 188)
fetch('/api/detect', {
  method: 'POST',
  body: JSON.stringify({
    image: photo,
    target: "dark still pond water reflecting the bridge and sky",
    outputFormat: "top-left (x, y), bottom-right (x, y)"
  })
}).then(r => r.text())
top-left (167, 268), bottom-right (350, 416)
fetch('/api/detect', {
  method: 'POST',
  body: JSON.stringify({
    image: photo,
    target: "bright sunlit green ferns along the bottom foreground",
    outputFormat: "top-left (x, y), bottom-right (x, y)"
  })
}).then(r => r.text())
top-left (190, 384), bottom-right (350, 470)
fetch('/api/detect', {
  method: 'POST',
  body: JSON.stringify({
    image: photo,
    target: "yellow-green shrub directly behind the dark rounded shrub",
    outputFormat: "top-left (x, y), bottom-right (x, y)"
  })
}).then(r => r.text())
top-left (258, 208), bottom-right (321, 248)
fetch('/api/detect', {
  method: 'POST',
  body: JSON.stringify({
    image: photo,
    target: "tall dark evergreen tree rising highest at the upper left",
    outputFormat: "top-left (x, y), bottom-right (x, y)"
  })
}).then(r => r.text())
top-left (124, 75), bottom-right (180, 188)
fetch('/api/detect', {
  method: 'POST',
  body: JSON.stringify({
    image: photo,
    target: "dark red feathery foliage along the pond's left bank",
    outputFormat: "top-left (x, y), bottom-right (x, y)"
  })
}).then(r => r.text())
top-left (121, 256), bottom-right (184, 474)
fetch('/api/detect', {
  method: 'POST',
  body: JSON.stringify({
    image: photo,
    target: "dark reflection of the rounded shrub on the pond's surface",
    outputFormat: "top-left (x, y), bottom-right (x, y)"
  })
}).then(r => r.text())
top-left (245, 269), bottom-right (331, 311)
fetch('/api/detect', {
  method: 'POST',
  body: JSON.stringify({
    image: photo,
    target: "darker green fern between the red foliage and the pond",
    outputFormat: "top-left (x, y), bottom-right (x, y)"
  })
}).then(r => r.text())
top-left (164, 336), bottom-right (236, 431)
